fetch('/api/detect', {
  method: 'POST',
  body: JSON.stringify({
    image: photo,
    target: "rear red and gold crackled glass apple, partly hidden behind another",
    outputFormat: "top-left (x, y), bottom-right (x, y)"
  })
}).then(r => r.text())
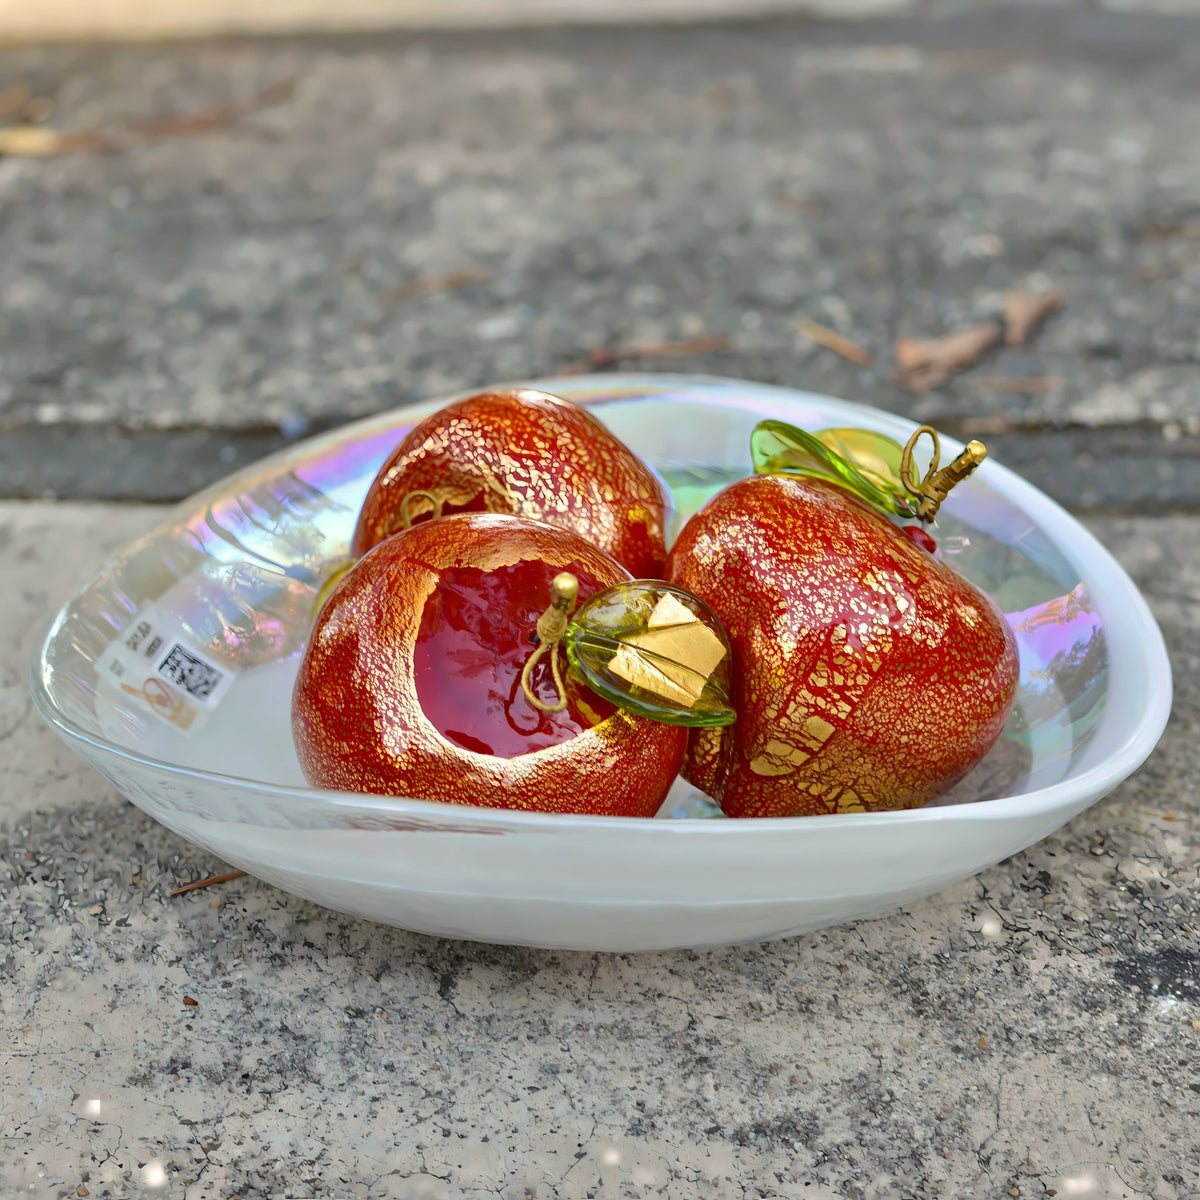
top-left (352, 388), bottom-right (671, 578)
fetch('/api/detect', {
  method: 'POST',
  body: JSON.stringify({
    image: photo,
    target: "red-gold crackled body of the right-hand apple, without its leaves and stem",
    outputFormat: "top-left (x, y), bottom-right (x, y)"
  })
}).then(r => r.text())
top-left (666, 474), bottom-right (1018, 816)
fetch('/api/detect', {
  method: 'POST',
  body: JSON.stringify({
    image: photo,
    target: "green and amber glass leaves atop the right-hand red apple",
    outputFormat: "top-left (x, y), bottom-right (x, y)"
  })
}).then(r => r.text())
top-left (750, 420), bottom-right (916, 517)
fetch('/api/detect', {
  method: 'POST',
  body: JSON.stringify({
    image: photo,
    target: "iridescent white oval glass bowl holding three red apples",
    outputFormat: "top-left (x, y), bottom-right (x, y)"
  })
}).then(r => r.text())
top-left (34, 374), bottom-right (1171, 952)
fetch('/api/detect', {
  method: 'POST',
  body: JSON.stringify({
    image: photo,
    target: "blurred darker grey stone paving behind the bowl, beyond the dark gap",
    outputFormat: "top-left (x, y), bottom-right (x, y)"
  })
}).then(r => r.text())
top-left (0, 5), bottom-right (1200, 468)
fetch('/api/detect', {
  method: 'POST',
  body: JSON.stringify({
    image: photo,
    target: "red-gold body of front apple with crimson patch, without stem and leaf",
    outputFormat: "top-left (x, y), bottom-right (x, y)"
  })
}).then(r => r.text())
top-left (293, 514), bottom-right (686, 816)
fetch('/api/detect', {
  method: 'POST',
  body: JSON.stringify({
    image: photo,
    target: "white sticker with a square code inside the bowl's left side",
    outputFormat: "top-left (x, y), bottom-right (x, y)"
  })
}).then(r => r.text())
top-left (98, 604), bottom-right (235, 733)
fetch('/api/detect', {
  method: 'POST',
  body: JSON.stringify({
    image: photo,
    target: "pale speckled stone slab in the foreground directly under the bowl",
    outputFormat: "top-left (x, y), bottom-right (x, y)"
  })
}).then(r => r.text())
top-left (0, 503), bottom-right (1200, 1200)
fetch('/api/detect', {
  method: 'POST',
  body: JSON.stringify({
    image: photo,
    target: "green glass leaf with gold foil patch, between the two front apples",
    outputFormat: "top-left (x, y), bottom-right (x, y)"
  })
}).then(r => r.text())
top-left (563, 580), bottom-right (737, 726)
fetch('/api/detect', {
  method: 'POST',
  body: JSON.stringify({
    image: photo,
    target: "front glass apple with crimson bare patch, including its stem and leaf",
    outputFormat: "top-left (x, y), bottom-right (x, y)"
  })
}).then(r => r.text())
top-left (293, 514), bottom-right (733, 817)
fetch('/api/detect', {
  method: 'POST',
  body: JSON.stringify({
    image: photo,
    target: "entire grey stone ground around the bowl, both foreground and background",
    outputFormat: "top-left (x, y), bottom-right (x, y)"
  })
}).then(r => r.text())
top-left (0, 4), bottom-right (1200, 1200)
